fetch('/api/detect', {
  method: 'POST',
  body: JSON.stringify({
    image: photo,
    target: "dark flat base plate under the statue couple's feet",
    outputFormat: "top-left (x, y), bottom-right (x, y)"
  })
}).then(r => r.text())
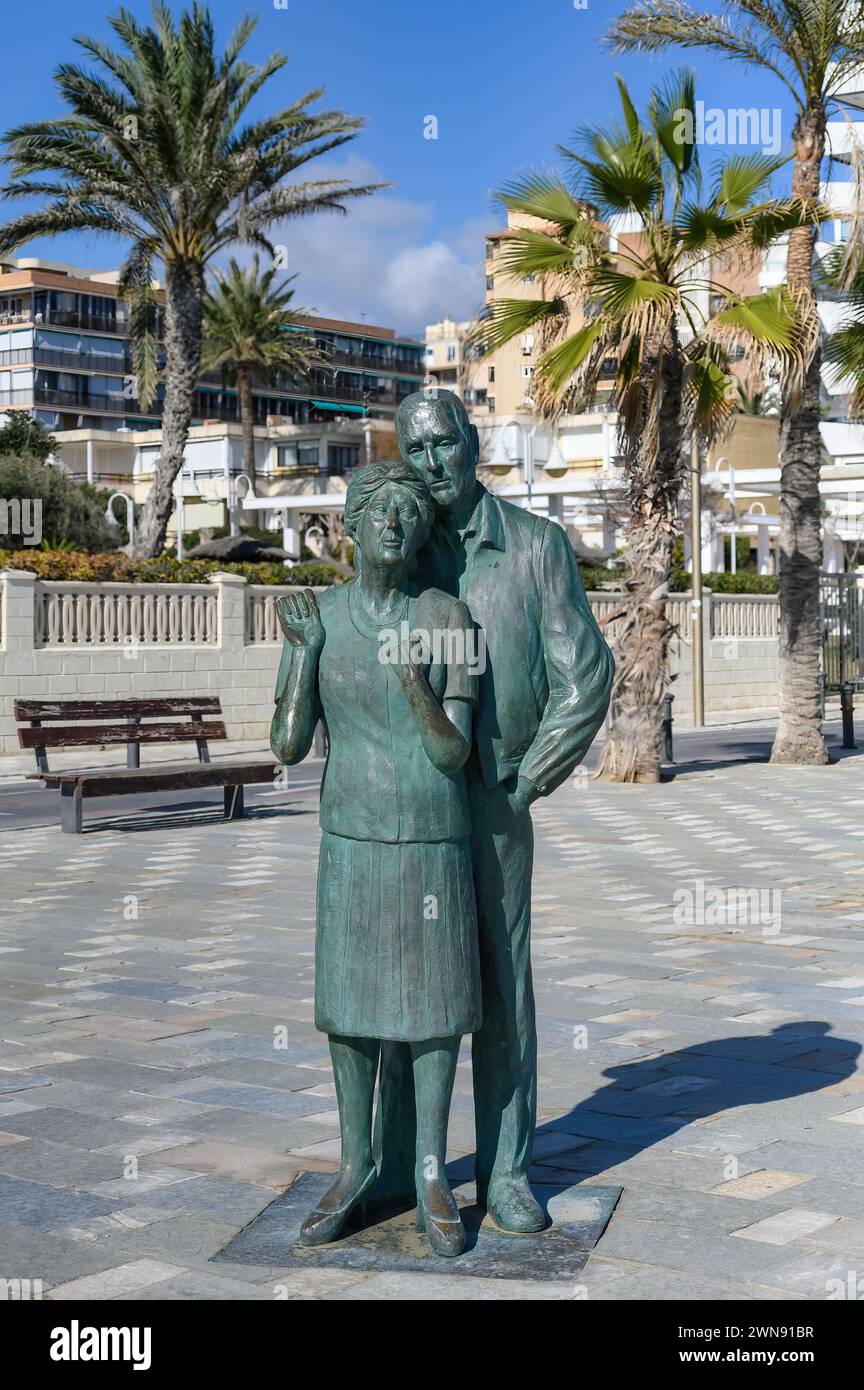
top-left (213, 1173), bottom-right (622, 1280)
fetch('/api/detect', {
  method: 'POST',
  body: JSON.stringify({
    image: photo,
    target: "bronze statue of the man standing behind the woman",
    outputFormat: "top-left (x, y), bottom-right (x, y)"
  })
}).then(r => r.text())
top-left (381, 391), bottom-right (614, 1232)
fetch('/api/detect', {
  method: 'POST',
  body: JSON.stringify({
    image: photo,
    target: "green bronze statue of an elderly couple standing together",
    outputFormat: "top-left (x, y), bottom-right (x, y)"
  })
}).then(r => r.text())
top-left (271, 391), bottom-right (613, 1255)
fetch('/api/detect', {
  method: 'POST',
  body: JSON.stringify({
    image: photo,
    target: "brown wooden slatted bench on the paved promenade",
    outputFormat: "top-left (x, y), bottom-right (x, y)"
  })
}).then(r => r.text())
top-left (15, 696), bottom-right (276, 834)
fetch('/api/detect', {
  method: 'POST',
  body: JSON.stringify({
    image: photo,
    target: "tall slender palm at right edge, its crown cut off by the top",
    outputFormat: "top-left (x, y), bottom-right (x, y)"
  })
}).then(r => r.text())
top-left (608, 0), bottom-right (864, 763)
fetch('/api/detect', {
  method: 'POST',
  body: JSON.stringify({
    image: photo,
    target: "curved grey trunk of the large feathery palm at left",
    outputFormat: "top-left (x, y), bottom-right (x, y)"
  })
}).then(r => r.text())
top-left (133, 261), bottom-right (204, 559)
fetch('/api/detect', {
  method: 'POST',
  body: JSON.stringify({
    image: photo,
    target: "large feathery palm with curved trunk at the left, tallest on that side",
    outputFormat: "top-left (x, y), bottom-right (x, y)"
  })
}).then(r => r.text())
top-left (0, 0), bottom-right (371, 556)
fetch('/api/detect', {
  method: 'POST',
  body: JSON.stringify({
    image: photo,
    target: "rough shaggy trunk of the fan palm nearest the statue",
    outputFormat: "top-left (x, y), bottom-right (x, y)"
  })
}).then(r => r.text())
top-left (599, 331), bottom-right (683, 783)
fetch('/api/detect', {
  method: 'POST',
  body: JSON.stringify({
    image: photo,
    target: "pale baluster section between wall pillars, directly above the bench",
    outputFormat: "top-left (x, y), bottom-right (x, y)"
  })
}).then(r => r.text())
top-left (35, 580), bottom-right (218, 646)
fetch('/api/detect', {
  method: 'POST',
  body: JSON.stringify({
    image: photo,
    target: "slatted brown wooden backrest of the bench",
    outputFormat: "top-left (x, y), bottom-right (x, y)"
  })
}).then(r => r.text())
top-left (14, 695), bottom-right (228, 773)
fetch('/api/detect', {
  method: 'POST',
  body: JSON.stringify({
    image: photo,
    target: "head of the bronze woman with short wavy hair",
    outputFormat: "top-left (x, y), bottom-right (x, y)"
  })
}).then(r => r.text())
top-left (344, 460), bottom-right (435, 564)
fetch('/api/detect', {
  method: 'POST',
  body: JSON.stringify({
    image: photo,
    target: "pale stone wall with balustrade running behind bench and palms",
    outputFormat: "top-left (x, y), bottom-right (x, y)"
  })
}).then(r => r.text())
top-left (0, 570), bottom-right (778, 753)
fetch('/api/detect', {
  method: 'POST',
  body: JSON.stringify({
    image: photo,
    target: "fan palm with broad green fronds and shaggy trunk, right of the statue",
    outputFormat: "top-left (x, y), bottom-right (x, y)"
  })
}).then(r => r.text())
top-left (475, 74), bottom-right (816, 781)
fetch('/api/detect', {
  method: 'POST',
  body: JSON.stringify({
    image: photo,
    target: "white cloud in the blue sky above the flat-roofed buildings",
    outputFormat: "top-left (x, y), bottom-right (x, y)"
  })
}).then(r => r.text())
top-left (261, 157), bottom-right (483, 335)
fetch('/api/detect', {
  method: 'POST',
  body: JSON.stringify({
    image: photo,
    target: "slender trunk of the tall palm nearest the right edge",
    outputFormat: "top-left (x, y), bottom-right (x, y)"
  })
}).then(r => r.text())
top-left (771, 107), bottom-right (828, 763)
